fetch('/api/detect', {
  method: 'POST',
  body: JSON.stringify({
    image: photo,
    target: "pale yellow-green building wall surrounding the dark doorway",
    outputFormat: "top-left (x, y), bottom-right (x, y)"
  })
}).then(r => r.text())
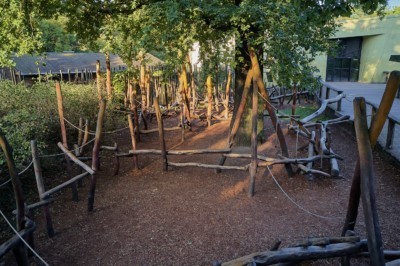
top-left (315, 15), bottom-right (400, 83)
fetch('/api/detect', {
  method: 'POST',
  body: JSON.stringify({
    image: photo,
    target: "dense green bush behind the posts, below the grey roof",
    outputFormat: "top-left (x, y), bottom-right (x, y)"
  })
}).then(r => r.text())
top-left (0, 81), bottom-right (126, 168)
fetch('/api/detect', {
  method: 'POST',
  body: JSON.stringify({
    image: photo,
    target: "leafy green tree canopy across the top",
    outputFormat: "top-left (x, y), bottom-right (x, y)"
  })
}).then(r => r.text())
top-left (0, 0), bottom-right (386, 85)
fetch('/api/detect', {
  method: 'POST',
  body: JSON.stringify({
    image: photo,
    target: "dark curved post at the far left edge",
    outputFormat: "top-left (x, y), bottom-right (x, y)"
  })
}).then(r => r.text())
top-left (0, 129), bottom-right (28, 265)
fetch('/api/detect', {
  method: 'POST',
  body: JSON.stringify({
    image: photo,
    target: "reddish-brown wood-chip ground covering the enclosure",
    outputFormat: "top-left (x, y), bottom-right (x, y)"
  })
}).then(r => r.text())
top-left (0, 108), bottom-right (400, 265)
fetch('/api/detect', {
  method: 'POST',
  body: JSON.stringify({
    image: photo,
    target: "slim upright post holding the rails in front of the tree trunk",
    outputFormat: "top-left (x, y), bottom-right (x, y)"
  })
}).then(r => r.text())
top-left (249, 80), bottom-right (258, 197)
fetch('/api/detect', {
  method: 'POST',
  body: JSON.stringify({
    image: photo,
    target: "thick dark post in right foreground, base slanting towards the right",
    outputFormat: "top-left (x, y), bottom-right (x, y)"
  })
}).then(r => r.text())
top-left (354, 97), bottom-right (384, 265)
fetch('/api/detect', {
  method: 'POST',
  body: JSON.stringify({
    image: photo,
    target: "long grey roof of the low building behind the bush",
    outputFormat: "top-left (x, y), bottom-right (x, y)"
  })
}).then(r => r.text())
top-left (13, 52), bottom-right (162, 75)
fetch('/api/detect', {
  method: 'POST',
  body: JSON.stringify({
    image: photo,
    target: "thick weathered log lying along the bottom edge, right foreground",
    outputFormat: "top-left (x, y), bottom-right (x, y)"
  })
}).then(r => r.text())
top-left (222, 240), bottom-right (367, 266)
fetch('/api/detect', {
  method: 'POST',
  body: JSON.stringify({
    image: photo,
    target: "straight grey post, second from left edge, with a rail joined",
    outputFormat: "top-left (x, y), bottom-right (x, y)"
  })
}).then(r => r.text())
top-left (31, 140), bottom-right (54, 237)
